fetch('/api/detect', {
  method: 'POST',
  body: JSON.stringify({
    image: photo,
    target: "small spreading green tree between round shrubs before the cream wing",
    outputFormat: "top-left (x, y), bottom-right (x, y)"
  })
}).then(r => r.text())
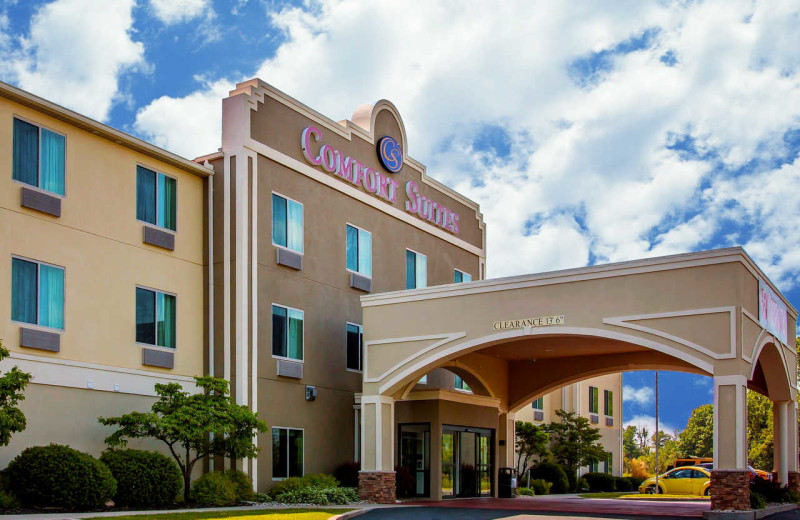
top-left (98, 377), bottom-right (267, 499)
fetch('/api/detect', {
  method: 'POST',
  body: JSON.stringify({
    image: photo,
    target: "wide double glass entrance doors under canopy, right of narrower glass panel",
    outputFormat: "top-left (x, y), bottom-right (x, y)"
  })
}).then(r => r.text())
top-left (442, 426), bottom-right (494, 497)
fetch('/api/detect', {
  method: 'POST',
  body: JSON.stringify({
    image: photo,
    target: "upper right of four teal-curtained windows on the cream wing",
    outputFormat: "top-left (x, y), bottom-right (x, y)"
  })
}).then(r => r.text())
top-left (136, 166), bottom-right (178, 231)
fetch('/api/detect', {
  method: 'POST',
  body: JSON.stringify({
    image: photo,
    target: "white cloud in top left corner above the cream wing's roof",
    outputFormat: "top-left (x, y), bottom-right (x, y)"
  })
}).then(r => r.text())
top-left (0, 0), bottom-right (146, 121)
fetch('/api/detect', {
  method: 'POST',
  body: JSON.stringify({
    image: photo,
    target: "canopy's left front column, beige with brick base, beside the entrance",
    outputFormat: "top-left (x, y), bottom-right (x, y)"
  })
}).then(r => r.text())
top-left (358, 395), bottom-right (397, 504)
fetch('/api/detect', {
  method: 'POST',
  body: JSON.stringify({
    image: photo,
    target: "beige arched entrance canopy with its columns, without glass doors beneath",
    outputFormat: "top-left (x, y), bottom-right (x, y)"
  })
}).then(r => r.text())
top-left (361, 249), bottom-right (797, 509)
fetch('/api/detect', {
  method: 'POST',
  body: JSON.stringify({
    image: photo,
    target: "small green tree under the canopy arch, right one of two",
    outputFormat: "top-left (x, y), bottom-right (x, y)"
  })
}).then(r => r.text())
top-left (545, 410), bottom-right (606, 488)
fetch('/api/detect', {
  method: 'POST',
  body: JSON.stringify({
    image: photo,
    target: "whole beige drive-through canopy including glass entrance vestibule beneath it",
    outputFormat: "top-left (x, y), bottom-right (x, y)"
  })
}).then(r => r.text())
top-left (359, 248), bottom-right (800, 509)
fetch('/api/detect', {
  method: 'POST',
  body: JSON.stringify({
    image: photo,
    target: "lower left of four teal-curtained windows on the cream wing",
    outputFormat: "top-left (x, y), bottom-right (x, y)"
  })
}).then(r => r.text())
top-left (11, 258), bottom-right (64, 329)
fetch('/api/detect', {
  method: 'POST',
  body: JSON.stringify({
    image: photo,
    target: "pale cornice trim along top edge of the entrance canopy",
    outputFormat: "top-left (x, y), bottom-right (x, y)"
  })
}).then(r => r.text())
top-left (361, 246), bottom-right (798, 319)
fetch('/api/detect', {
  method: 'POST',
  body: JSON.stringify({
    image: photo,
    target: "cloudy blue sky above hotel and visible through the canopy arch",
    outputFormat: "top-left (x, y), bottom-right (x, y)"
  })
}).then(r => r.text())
top-left (0, 0), bottom-right (800, 434)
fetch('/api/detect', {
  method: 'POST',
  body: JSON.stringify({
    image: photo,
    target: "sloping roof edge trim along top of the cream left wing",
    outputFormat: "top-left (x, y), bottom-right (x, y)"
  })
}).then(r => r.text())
top-left (0, 81), bottom-right (214, 177)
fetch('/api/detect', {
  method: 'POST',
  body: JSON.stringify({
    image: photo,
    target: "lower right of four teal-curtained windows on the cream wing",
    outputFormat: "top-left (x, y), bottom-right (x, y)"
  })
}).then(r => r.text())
top-left (136, 287), bottom-right (177, 348)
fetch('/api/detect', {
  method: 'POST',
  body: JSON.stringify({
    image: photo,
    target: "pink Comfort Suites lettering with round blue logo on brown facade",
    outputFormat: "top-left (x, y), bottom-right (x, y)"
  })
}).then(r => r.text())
top-left (300, 126), bottom-right (459, 234)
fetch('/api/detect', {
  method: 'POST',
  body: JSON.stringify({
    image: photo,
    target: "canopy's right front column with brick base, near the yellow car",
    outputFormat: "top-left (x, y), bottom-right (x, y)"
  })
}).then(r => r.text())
top-left (711, 375), bottom-right (750, 511)
